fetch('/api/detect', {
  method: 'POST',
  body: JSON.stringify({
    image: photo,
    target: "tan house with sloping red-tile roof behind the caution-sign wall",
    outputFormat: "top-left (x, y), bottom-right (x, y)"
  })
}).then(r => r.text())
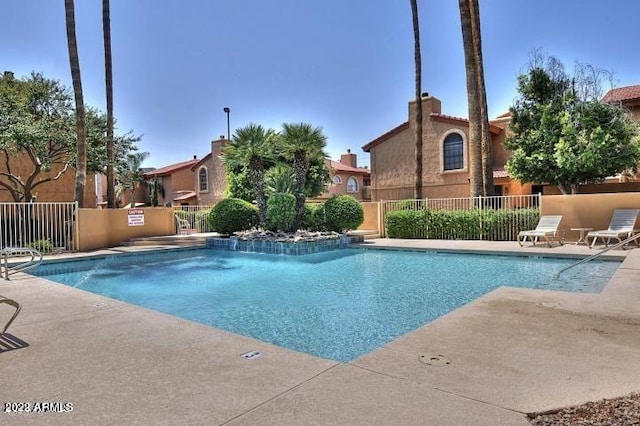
top-left (143, 155), bottom-right (199, 206)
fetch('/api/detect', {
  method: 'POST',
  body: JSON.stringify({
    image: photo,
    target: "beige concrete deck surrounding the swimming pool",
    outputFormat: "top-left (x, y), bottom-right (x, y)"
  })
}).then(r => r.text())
top-left (0, 239), bottom-right (640, 426)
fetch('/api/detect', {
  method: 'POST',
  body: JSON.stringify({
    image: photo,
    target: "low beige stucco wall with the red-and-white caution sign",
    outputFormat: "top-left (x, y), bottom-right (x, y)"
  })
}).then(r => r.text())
top-left (76, 207), bottom-right (175, 251)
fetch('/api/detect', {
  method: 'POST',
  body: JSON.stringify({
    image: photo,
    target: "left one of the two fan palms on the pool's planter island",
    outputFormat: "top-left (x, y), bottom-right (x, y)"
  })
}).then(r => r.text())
top-left (223, 123), bottom-right (276, 226)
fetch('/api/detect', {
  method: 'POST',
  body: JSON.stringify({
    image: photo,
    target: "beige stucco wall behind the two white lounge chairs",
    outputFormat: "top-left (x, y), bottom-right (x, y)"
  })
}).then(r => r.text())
top-left (540, 192), bottom-right (640, 241)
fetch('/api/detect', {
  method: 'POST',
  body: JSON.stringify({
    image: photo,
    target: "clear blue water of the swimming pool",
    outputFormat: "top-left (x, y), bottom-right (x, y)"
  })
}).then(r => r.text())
top-left (36, 249), bottom-right (619, 362)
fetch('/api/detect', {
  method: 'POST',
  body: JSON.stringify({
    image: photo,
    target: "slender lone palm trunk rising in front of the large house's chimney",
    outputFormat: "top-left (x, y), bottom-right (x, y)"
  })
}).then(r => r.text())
top-left (410, 0), bottom-right (422, 199)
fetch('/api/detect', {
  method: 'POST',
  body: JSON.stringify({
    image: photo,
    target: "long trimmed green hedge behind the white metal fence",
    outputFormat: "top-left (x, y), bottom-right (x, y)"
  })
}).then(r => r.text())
top-left (385, 209), bottom-right (540, 241)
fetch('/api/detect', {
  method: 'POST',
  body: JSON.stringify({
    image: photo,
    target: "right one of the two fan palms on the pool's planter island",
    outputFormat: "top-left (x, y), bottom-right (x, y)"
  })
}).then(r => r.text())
top-left (280, 123), bottom-right (327, 232)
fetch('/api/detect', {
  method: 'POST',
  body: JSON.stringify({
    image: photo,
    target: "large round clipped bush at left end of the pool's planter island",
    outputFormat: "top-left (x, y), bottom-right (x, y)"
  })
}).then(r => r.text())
top-left (209, 198), bottom-right (258, 234)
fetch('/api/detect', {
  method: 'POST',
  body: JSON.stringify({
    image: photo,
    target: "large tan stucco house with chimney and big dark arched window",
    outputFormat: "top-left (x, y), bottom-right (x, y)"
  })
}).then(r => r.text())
top-left (362, 94), bottom-right (537, 201)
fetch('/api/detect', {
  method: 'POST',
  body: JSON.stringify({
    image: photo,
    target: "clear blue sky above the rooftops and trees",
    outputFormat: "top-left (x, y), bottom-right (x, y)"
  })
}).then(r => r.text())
top-left (0, 0), bottom-right (640, 167)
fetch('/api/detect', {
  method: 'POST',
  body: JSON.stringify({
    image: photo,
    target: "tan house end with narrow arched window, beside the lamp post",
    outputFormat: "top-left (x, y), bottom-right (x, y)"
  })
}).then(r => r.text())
top-left (191, 136), bottom-right (227, 206)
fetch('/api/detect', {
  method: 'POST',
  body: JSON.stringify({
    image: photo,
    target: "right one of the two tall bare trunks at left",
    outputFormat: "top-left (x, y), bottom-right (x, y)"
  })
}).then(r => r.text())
top-left (102, 0), bottom-right (116, 209)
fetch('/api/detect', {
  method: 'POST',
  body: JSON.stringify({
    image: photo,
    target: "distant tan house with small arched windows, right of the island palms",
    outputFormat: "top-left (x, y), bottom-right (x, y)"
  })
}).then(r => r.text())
top-left (312, 149), bottom-right (371, 201)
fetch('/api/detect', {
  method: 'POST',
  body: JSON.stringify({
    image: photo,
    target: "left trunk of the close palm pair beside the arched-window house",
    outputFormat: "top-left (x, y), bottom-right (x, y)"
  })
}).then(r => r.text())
top-left (458, 0), bottom-right (482, 197)
